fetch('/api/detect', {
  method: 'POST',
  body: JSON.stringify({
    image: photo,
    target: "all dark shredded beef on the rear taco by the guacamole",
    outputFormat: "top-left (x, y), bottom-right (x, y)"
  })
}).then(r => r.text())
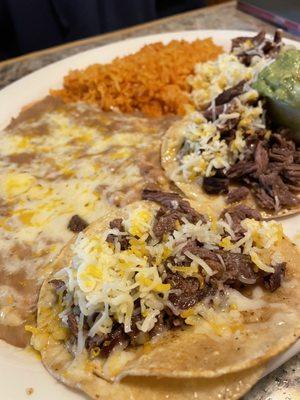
top-left (188, 30), bottom-right (300, 212)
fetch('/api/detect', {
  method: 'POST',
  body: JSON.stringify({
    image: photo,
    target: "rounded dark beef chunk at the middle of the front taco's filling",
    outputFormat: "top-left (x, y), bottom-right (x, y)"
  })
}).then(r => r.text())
top-left (165, 272), bottom-right (208, 310)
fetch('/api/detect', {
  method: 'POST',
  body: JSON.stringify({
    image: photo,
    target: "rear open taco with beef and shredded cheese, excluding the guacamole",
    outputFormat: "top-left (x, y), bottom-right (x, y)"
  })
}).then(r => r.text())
top-left (161, 30), bottom-right (300, 218)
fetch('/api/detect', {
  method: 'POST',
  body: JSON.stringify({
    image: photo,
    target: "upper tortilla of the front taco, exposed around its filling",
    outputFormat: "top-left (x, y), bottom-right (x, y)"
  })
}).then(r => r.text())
top-left (37, 202), bottom-right (300, 380)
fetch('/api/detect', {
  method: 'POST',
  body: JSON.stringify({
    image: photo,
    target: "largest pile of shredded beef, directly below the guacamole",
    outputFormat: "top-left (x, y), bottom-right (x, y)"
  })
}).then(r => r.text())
top-left (226, 132), bottom-right (300, 211)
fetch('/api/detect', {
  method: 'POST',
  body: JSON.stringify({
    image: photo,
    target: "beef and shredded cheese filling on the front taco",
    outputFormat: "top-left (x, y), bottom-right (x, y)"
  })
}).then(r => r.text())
top-left (49, 190), bottom-right (285, 360)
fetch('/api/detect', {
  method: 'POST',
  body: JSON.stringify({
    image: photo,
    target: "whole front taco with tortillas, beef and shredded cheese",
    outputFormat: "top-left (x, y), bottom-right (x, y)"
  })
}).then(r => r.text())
top-left (32, 190), bottom-right (300, 398)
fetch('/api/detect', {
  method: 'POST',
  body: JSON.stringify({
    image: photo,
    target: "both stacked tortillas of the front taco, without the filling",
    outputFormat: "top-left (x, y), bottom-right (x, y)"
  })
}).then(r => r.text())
top-left (32, 201), bottom-right (300, 390)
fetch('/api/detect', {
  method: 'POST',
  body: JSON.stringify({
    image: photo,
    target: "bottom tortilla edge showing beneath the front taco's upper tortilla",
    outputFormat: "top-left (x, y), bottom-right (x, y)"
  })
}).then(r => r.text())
top-left (37, 328), bottom-right (265, 400)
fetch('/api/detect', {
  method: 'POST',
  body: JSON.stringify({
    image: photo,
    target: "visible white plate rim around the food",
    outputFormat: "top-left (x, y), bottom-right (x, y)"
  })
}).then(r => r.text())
top-left (0, 30), bottom-right (300, 400)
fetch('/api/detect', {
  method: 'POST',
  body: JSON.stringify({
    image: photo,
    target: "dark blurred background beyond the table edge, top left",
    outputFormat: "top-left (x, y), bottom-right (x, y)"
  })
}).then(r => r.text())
top-left (0, 0), bottom-right (223, 60)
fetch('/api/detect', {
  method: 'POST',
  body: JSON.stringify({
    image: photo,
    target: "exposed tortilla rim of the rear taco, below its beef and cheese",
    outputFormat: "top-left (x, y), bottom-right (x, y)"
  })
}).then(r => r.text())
top-left (161, 120), bottom-right (300, 220)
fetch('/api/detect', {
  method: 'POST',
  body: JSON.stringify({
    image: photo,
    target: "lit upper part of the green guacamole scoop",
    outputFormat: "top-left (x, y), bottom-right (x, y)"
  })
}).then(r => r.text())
top-left (252, 49), bottom-right (300, 108)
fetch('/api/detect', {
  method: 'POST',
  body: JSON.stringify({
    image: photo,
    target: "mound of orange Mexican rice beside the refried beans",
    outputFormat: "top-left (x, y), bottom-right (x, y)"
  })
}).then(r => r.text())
top-left (51, 38), bottom-right (222, 116)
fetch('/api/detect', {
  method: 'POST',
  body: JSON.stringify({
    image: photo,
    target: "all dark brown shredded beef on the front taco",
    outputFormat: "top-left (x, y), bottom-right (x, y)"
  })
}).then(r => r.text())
top-left (54, 190), bottom-right (285, 358)
